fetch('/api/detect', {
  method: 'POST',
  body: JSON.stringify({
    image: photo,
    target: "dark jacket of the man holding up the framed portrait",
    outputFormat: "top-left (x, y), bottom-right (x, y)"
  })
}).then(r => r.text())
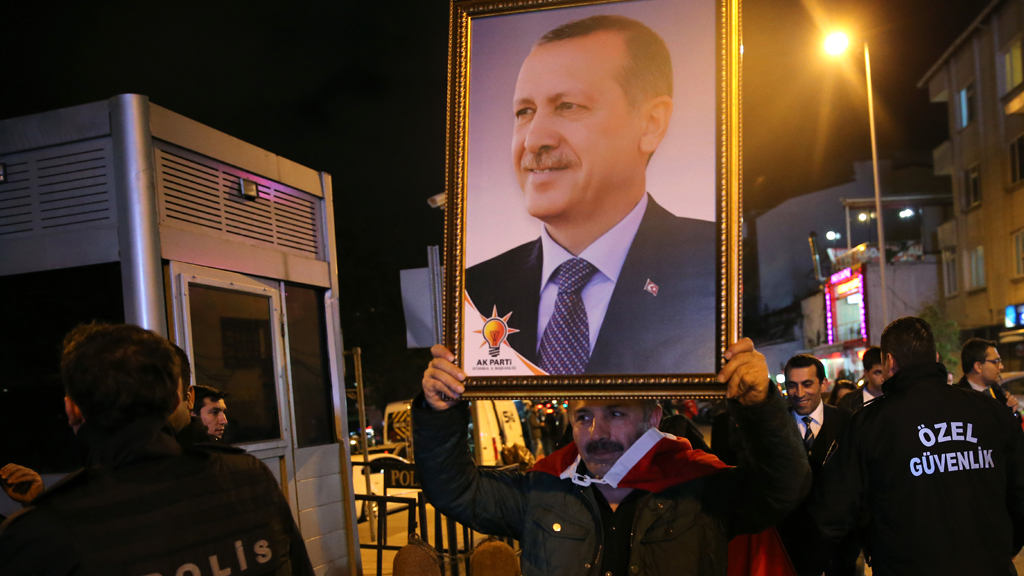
top-left (413, 386), bottom-right (811, 576)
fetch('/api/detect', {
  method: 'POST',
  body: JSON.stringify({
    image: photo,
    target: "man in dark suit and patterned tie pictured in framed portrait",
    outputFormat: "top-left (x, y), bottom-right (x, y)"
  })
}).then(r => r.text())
top-left (466, 15), bottom-right (717, 374)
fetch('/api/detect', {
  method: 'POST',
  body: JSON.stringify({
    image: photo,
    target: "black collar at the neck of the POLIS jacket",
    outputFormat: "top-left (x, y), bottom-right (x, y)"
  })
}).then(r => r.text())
top-left (76, 418), bottom-right (181, 469)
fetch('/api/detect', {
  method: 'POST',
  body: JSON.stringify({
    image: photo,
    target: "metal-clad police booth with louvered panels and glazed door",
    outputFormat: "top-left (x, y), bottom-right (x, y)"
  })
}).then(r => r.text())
top-left (0, 94), bottom-right (359, 575)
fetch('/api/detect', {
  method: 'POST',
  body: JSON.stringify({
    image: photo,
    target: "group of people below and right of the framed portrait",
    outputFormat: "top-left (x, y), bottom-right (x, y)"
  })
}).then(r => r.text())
top-left (413, 317), bottom-right (1024, 576)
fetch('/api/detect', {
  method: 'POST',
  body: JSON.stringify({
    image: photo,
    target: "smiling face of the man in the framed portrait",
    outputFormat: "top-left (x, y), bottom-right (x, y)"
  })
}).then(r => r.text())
top-left (512, 31), bottom-right (672, 241)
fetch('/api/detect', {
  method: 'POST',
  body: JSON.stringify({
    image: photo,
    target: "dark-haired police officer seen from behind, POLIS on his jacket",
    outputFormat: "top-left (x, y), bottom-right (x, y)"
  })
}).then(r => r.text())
top-left (0, 324), bottom-right (313, 576)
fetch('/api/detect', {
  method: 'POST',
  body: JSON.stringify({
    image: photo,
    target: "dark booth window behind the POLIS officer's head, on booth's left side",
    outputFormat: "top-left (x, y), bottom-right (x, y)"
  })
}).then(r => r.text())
top-left (0, 262), bottom-right (125, 474)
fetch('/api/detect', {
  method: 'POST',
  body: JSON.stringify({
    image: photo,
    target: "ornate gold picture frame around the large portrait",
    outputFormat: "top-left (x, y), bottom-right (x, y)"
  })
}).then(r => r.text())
top-left (443, 0), bottom-right (742, 399)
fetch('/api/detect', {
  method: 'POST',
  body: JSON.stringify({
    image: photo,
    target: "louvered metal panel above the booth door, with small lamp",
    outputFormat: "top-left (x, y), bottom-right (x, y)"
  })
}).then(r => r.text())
top-left (155, 140), bottom-right (325, 260)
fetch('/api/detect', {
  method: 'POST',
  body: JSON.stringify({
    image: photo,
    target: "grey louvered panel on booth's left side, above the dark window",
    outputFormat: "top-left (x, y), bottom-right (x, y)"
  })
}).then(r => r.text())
top-left (0, 138), bottom-right (116, 237)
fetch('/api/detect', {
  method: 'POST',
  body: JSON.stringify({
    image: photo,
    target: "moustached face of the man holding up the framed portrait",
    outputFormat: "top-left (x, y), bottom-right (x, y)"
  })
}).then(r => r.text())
top-left (570, 400), bottom-right (662, 478)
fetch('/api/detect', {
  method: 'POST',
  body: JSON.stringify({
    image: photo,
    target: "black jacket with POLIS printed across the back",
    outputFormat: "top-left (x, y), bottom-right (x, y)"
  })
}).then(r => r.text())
top-left (0, 420), bottom-right (313, 576)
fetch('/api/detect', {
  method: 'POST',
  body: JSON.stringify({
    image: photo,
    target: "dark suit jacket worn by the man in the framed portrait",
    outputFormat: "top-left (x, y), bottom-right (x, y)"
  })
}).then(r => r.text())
top-left (466, 198), bottom-right (718, 374)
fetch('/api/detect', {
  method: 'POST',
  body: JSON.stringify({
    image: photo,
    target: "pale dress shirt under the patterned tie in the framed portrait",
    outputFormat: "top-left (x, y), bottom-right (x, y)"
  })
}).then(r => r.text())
top-left (537, 194), bottom-right (647, 352)
